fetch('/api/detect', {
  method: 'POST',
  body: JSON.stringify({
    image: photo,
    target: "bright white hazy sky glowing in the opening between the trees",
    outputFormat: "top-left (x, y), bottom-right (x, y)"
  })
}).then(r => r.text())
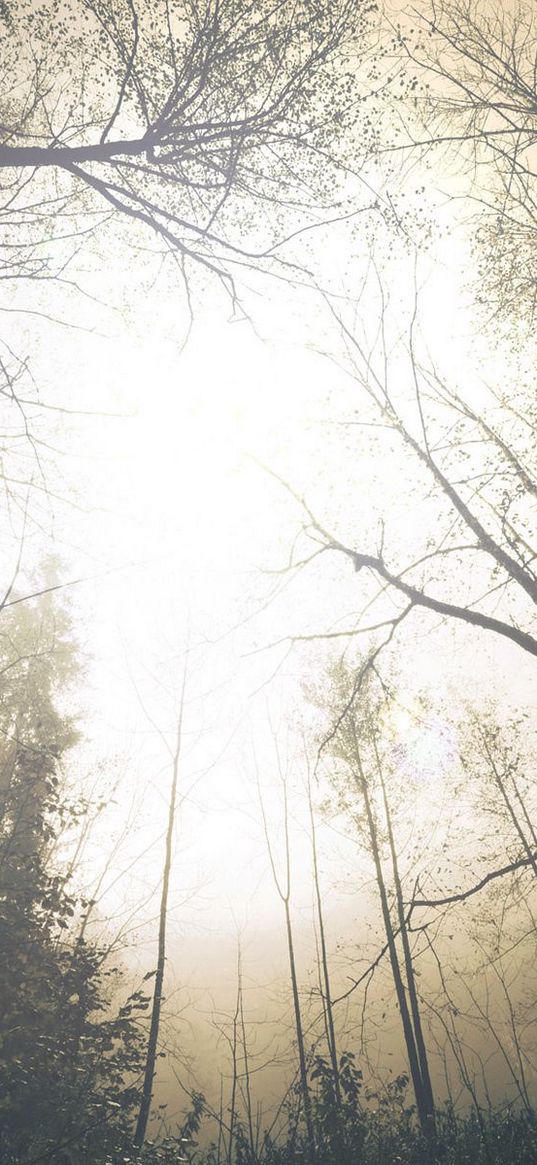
top-left (1, 152), bottom-right (527, 1118)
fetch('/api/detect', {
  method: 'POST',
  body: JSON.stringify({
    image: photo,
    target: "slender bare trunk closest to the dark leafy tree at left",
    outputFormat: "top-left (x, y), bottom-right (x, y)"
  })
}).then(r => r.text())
top-left (134, 665), bottom-right (186, 1149)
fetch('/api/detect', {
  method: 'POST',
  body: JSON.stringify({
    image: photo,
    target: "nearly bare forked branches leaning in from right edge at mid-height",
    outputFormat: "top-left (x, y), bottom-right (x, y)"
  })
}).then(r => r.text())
top-left (273, 259), bottom-right (537, 671)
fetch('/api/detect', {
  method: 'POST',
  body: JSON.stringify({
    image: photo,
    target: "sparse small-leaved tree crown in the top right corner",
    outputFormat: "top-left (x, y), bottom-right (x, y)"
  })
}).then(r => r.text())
top-left (396, 0), bottom-right (537, 334)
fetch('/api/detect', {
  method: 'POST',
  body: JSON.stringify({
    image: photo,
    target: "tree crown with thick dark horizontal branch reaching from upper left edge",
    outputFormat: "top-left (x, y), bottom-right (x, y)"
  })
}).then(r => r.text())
top-left (0, 0), bottom-right (373, 298)
